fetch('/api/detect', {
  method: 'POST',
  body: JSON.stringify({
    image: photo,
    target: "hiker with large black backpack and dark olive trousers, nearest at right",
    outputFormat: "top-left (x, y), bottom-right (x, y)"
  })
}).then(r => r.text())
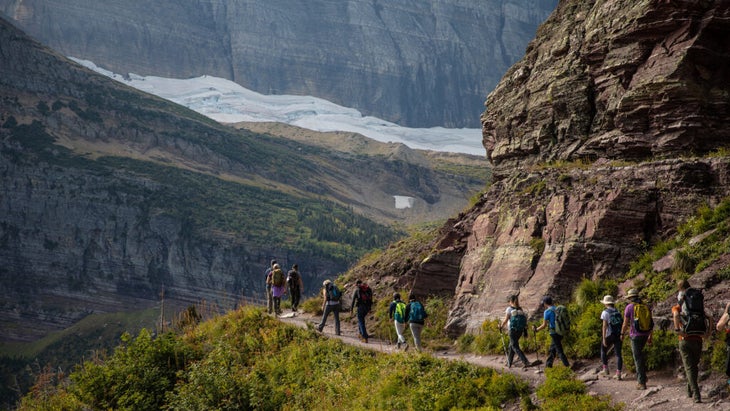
top-left (672, 280), bottom-right (709, 403)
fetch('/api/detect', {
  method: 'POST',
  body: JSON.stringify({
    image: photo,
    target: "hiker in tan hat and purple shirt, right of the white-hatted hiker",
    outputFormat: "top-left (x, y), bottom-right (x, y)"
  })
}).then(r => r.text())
top-left (621, 288), bottom-right (654, 390)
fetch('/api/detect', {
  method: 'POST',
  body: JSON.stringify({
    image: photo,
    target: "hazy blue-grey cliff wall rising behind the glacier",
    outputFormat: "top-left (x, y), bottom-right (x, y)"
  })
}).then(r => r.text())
top-left (0, 0), bottom-right (557, 127)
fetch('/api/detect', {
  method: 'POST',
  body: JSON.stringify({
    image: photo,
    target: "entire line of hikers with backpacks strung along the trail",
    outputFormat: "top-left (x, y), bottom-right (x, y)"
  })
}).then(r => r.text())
top-left (258, 260), bottom-right (730, 403)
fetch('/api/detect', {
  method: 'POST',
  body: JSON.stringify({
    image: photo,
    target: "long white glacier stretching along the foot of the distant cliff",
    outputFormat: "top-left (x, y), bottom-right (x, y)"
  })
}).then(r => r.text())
top-left (70, 57), bottom-right (486, 156)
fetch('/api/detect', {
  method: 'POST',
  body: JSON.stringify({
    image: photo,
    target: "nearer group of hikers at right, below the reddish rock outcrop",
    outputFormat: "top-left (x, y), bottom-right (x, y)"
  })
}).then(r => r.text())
top-left (499, 280), bottom-right (730, 403)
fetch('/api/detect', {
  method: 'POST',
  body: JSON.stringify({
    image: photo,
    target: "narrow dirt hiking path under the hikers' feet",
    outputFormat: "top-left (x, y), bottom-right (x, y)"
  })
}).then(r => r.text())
top-left (279, 312), bottom-right (730, 411)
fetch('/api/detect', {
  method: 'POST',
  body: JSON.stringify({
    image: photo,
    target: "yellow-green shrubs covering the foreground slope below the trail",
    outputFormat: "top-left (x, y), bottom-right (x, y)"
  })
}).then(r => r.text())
top-left (20, 307), bottom-right (530, 410)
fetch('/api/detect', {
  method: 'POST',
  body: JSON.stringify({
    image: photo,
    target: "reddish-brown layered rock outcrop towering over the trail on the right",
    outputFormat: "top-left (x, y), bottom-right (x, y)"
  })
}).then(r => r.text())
top-left (404, 0), bottom-right (730, 334)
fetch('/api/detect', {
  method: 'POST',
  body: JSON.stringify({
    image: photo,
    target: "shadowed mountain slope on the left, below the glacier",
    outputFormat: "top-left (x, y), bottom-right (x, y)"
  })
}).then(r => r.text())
top-left (0, 15), bottom-right (484, 340)
